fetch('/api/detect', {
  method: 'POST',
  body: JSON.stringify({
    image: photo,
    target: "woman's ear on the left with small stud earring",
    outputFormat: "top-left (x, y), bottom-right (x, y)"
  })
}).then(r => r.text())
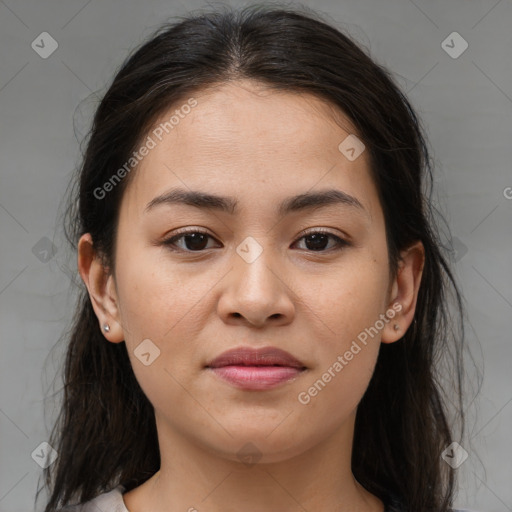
top-left (78, 233), bottom-right (124, 343)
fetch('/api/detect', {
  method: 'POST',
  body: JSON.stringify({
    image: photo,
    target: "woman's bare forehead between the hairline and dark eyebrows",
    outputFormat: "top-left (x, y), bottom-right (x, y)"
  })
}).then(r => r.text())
top-left (118, 81), bottom-right (378, 222)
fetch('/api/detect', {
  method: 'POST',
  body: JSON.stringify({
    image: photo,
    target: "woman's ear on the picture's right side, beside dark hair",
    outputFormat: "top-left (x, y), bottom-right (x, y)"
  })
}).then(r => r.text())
top-left (381, 241), bottom-right (425, 343)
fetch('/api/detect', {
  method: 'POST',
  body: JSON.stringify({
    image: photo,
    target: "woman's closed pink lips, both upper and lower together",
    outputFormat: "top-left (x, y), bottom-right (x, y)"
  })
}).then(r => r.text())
top-left (205, 347), bottom-right (307, 390)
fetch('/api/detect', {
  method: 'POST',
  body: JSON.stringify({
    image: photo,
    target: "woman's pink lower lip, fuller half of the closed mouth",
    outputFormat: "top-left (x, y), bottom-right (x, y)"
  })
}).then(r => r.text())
top-left (210, 366), bottom-right (304, 390)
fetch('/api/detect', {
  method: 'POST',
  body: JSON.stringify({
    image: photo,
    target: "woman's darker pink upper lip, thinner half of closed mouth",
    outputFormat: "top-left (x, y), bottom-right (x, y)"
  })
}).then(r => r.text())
top-left (206, 347), bottom-right (306, 369)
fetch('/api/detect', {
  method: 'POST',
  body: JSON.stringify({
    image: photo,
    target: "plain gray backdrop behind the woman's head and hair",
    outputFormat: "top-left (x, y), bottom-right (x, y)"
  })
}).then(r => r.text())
top-left (0, 0), bottom-right (512, 512)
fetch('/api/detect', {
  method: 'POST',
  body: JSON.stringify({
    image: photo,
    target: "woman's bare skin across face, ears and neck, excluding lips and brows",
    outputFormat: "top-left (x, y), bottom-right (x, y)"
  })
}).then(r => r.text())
top-left (78, 77), bottom-right (424, 512)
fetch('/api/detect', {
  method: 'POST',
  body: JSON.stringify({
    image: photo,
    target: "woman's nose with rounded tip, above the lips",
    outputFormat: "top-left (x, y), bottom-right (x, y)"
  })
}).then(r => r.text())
top-left (218, 244), bottom-right (297, 327)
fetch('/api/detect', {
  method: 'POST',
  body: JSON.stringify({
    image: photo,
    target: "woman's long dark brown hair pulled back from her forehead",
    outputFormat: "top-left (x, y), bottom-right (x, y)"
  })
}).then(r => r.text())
top-left (38, 4), bottom-right (472, 512)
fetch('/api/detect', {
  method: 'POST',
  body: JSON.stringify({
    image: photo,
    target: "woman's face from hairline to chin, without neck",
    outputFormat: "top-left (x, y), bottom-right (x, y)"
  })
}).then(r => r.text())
top-left (80, 81), bottom-right (418, 462)
